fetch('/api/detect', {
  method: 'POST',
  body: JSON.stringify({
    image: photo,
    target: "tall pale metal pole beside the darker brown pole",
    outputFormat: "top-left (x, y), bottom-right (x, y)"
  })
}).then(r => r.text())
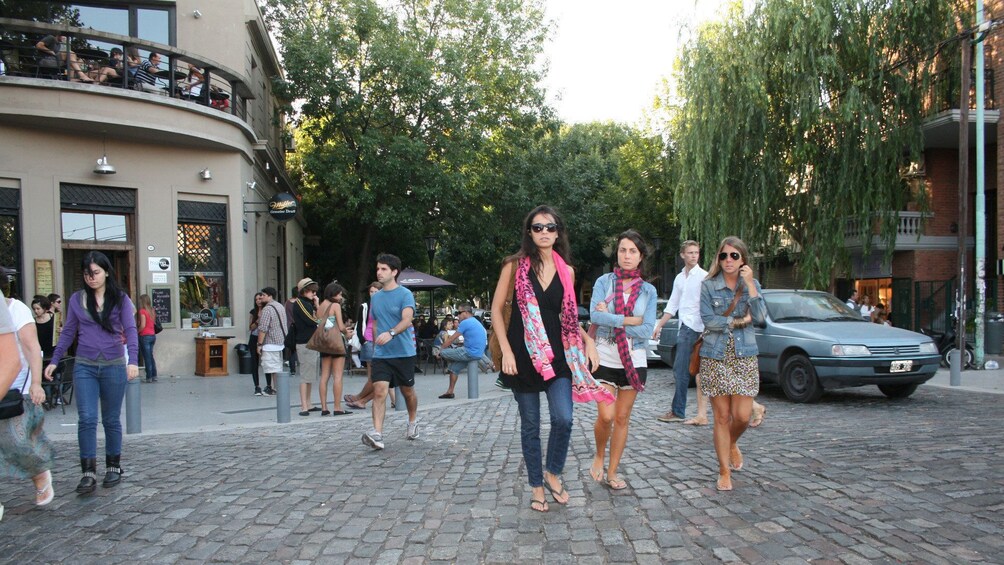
top-left (975, 0), bottom-right (987, 368)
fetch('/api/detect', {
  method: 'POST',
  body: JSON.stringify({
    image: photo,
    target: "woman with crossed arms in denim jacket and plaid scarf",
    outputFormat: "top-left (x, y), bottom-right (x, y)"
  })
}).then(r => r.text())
top-left (589, 230), bottom-right (657, 491)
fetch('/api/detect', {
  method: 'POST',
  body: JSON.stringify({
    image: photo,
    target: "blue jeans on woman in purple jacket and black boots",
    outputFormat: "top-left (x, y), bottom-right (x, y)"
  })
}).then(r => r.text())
top-left (73, 358), bottom-right (129, 459)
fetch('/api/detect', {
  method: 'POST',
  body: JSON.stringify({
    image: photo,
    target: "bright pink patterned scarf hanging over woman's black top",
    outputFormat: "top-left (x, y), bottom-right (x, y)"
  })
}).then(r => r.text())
top-left (515, 253), bottom-right (616, 403)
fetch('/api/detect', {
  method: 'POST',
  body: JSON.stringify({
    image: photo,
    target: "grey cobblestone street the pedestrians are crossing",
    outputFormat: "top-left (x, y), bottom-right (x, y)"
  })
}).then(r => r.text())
top-left (0, 369), bottom-right (1004, 563)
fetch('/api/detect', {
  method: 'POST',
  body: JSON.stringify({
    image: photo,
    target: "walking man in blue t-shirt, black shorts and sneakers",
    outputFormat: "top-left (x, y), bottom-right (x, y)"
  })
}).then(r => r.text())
top-left (362, 254), bottom-right (419, 450)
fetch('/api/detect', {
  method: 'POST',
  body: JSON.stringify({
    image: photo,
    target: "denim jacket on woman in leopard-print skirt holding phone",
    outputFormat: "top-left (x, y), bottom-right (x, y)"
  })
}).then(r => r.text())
top-left (701, 273), bottom-right (767, 360)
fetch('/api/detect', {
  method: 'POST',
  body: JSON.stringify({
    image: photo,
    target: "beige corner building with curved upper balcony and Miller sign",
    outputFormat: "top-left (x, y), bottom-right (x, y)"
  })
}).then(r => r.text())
top-left (0, 0), bottom-right (303, 374)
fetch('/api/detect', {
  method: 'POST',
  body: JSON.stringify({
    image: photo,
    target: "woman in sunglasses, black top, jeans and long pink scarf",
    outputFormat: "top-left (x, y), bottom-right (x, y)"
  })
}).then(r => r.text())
top-left (492, 206), bottom-right (613, 512)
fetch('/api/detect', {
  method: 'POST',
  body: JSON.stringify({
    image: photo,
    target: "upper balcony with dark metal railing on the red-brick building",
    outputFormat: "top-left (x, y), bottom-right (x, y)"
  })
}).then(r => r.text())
top-left (923, 67), bottom-right (1000, 149)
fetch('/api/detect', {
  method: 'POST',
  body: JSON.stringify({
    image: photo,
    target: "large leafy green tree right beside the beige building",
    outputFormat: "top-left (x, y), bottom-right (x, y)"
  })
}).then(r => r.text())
top-left (266, 0), bottom-right (546, 301)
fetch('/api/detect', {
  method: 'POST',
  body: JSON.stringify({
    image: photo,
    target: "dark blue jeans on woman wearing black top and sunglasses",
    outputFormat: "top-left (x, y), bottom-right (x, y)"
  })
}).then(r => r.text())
top-left (512, 378), bottom-right (571, 488)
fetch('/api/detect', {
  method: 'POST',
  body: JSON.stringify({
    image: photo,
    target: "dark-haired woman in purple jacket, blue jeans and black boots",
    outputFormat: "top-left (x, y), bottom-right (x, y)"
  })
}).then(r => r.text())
top-left (45, 251), bottom-right (140, 494)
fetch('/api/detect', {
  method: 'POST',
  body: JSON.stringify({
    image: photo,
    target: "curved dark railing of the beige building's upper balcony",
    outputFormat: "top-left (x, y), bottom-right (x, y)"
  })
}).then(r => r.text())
top-left (0, 18), bottom-right (254, 121)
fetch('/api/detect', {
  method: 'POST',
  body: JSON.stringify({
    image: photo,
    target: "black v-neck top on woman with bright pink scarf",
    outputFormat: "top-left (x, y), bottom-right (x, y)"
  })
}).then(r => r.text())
top-left (501, 270), bottom-right (571, 392)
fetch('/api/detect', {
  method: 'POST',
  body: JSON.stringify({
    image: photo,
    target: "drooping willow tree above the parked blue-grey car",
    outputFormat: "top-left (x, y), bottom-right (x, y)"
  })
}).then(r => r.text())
top-left (672, 0), bottom-right (969, 288)
